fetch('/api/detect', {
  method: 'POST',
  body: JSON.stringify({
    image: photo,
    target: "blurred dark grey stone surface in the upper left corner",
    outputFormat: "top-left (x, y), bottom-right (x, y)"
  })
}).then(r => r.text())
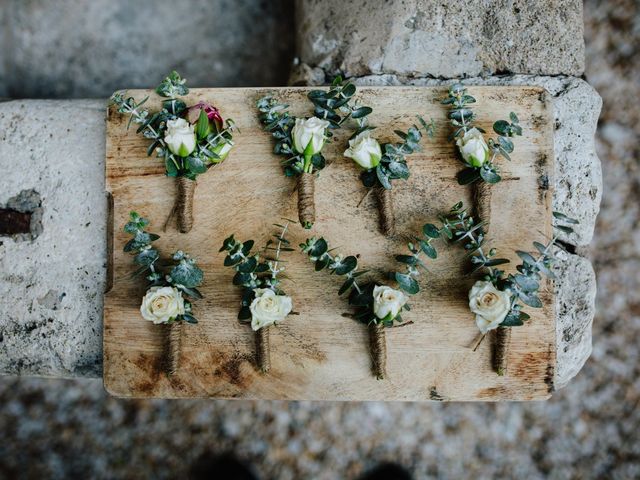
top-left (0, 0), bottom-right (294, 98)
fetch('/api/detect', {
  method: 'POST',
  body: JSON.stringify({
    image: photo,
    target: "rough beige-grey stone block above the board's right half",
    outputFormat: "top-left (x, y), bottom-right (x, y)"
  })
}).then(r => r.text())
top-left (297, 0), bottom-right (584, 78)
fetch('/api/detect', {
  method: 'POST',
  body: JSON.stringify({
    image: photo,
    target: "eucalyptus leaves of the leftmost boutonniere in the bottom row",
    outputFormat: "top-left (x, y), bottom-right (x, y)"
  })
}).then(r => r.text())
top-left (124, 212), bottom-right (204, 323)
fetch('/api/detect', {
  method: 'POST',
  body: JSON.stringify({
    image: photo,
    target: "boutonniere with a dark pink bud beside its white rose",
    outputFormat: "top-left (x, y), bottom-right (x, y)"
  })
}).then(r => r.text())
top-left (111, 71), bottom-right (236, 233)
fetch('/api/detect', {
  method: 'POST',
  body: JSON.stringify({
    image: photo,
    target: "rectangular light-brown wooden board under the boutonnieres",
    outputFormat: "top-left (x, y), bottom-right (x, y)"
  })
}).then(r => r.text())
top-left (104, 87), bottom-right (555, 401)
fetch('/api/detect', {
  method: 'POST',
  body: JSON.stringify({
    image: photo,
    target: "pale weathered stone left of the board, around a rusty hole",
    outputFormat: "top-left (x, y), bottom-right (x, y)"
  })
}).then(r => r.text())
top-left (0, 100), bottom-right (107, 377)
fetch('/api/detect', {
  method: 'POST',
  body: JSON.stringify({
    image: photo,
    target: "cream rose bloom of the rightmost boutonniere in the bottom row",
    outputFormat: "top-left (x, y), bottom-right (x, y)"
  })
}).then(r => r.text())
top-left (469, 281), bottom-right (511, 334)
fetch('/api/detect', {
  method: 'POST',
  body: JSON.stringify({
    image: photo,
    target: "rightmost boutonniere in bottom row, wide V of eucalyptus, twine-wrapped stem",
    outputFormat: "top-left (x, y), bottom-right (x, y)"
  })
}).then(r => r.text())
top-left (443, 203), bottom-right (578, 375)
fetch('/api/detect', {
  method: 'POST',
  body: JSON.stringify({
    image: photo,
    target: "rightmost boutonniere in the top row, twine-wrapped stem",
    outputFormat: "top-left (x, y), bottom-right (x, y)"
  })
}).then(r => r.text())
top-left (442, 83), bottom-right (522, 234)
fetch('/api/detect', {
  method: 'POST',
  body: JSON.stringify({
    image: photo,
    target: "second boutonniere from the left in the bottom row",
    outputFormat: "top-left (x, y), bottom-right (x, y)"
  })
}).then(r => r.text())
top-left (220, 222), bottom-right (293, 373)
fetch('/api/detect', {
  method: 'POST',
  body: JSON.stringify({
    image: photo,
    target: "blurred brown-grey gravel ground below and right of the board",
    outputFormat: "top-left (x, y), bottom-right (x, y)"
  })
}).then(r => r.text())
top-left (0, 0), bottom-right (640, 479)
